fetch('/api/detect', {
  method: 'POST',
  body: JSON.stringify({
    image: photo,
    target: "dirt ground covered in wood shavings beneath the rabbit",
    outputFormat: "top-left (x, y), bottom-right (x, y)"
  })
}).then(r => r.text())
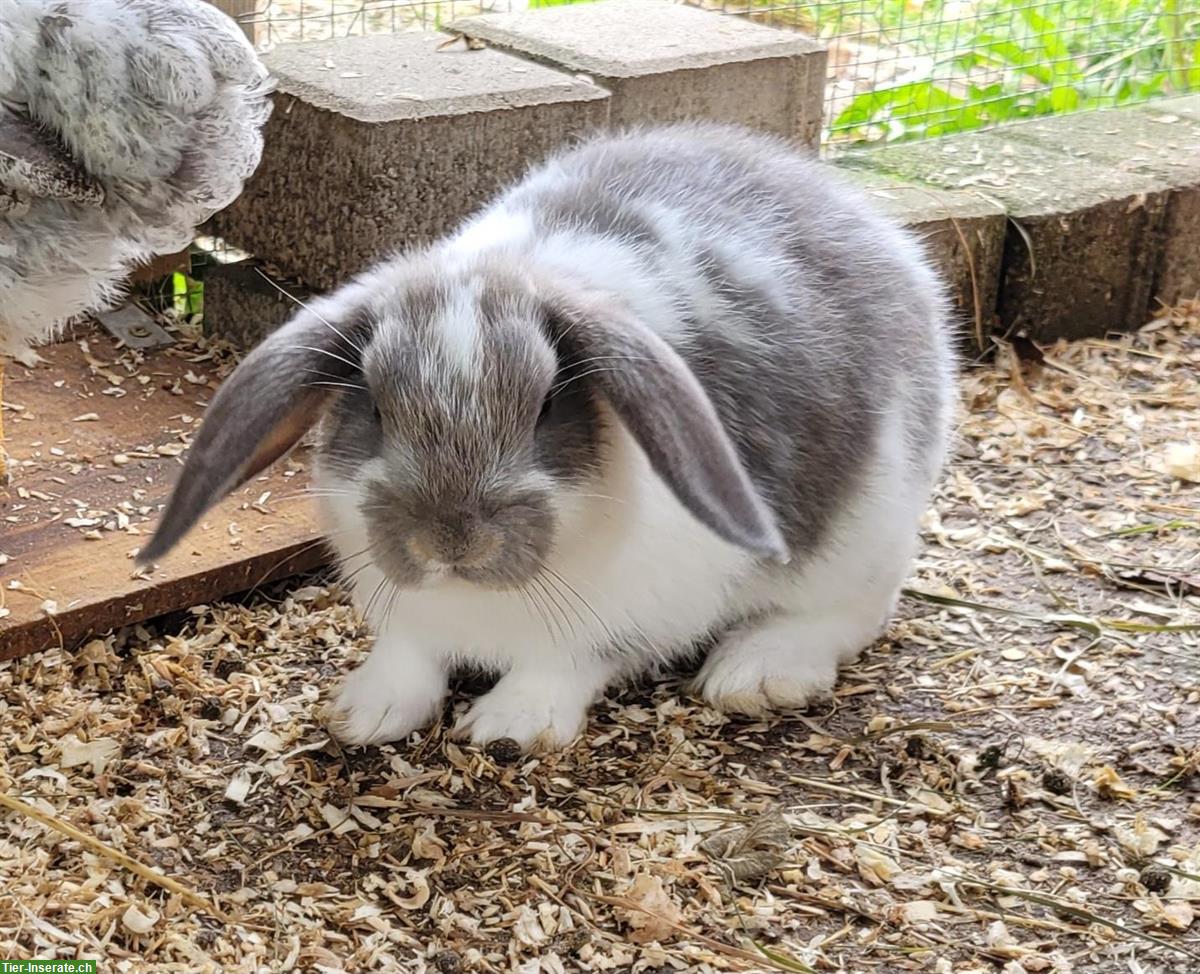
top-left (0, 303), bottom-right (1200, 974)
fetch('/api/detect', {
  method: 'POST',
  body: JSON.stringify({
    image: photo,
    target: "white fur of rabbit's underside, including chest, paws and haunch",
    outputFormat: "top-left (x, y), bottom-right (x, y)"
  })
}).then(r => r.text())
top-left (318, 391), bottom-right (928, 747)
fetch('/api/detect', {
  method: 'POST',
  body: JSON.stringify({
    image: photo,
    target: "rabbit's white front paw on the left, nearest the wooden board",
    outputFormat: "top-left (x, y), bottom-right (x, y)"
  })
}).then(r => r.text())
top-left (325, 650), bottom-right (446, 745)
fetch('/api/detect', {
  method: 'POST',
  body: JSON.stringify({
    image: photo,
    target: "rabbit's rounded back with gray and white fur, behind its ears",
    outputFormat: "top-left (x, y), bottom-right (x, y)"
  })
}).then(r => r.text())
top-left (489, 126), bottom-right (953, 552)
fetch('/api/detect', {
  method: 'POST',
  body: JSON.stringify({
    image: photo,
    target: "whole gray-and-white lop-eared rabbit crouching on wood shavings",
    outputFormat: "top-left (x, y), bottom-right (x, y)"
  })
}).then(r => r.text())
top-left (143, 125), bottom-right (953, 747)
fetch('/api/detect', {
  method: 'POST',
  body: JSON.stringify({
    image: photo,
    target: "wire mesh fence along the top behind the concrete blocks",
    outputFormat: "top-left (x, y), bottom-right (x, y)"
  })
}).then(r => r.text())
top-left (223, 0), bottom-right (1200, 144)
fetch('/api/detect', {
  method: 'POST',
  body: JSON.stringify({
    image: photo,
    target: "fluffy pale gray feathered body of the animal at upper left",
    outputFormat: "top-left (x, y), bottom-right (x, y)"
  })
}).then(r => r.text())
top-left (0, 0), bottom-right (271, 355)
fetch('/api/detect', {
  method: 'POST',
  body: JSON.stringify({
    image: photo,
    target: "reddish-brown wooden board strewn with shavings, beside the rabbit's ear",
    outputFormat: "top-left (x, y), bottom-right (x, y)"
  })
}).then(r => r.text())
top-left (0, 329), bottom-right (328, 660)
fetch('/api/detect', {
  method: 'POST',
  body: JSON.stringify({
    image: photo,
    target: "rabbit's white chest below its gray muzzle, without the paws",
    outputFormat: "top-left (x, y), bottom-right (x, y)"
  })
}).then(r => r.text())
top-left (323, 435), bottom-right (755, 668)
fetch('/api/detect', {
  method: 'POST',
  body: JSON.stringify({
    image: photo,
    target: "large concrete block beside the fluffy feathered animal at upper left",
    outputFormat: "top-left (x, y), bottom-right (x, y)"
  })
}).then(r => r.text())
top-left (210, 32), bottom-right (608, 289)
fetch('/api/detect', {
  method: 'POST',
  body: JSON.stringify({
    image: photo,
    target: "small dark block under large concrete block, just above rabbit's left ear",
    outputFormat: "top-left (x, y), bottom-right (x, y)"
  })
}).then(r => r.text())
top-left (203, 260), bottom-right (310, 350)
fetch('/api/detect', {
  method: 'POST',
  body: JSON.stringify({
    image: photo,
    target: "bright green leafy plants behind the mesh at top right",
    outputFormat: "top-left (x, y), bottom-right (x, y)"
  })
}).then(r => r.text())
top-left (825, 0), bottom-right (1200, 140)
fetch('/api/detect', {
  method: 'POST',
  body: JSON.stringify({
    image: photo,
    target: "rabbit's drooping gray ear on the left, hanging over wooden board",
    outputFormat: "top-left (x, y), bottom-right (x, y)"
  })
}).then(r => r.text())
top-left (137, 299), bottom-right (368, 564)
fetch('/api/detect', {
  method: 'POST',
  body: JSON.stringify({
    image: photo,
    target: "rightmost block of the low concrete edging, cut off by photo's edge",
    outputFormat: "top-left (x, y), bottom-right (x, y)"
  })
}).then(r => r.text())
top-left (1006, 104), bottom-right (1200, 305)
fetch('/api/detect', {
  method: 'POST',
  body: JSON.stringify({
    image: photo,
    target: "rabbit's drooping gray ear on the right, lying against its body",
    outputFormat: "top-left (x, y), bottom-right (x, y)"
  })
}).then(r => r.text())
top-left (546, 283), bottom-right (790, 563)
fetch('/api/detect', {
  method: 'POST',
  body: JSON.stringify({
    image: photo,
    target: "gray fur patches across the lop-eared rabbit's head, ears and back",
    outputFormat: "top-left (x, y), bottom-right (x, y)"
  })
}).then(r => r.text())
top-left (145, 126), bottom-right (950, 588)
